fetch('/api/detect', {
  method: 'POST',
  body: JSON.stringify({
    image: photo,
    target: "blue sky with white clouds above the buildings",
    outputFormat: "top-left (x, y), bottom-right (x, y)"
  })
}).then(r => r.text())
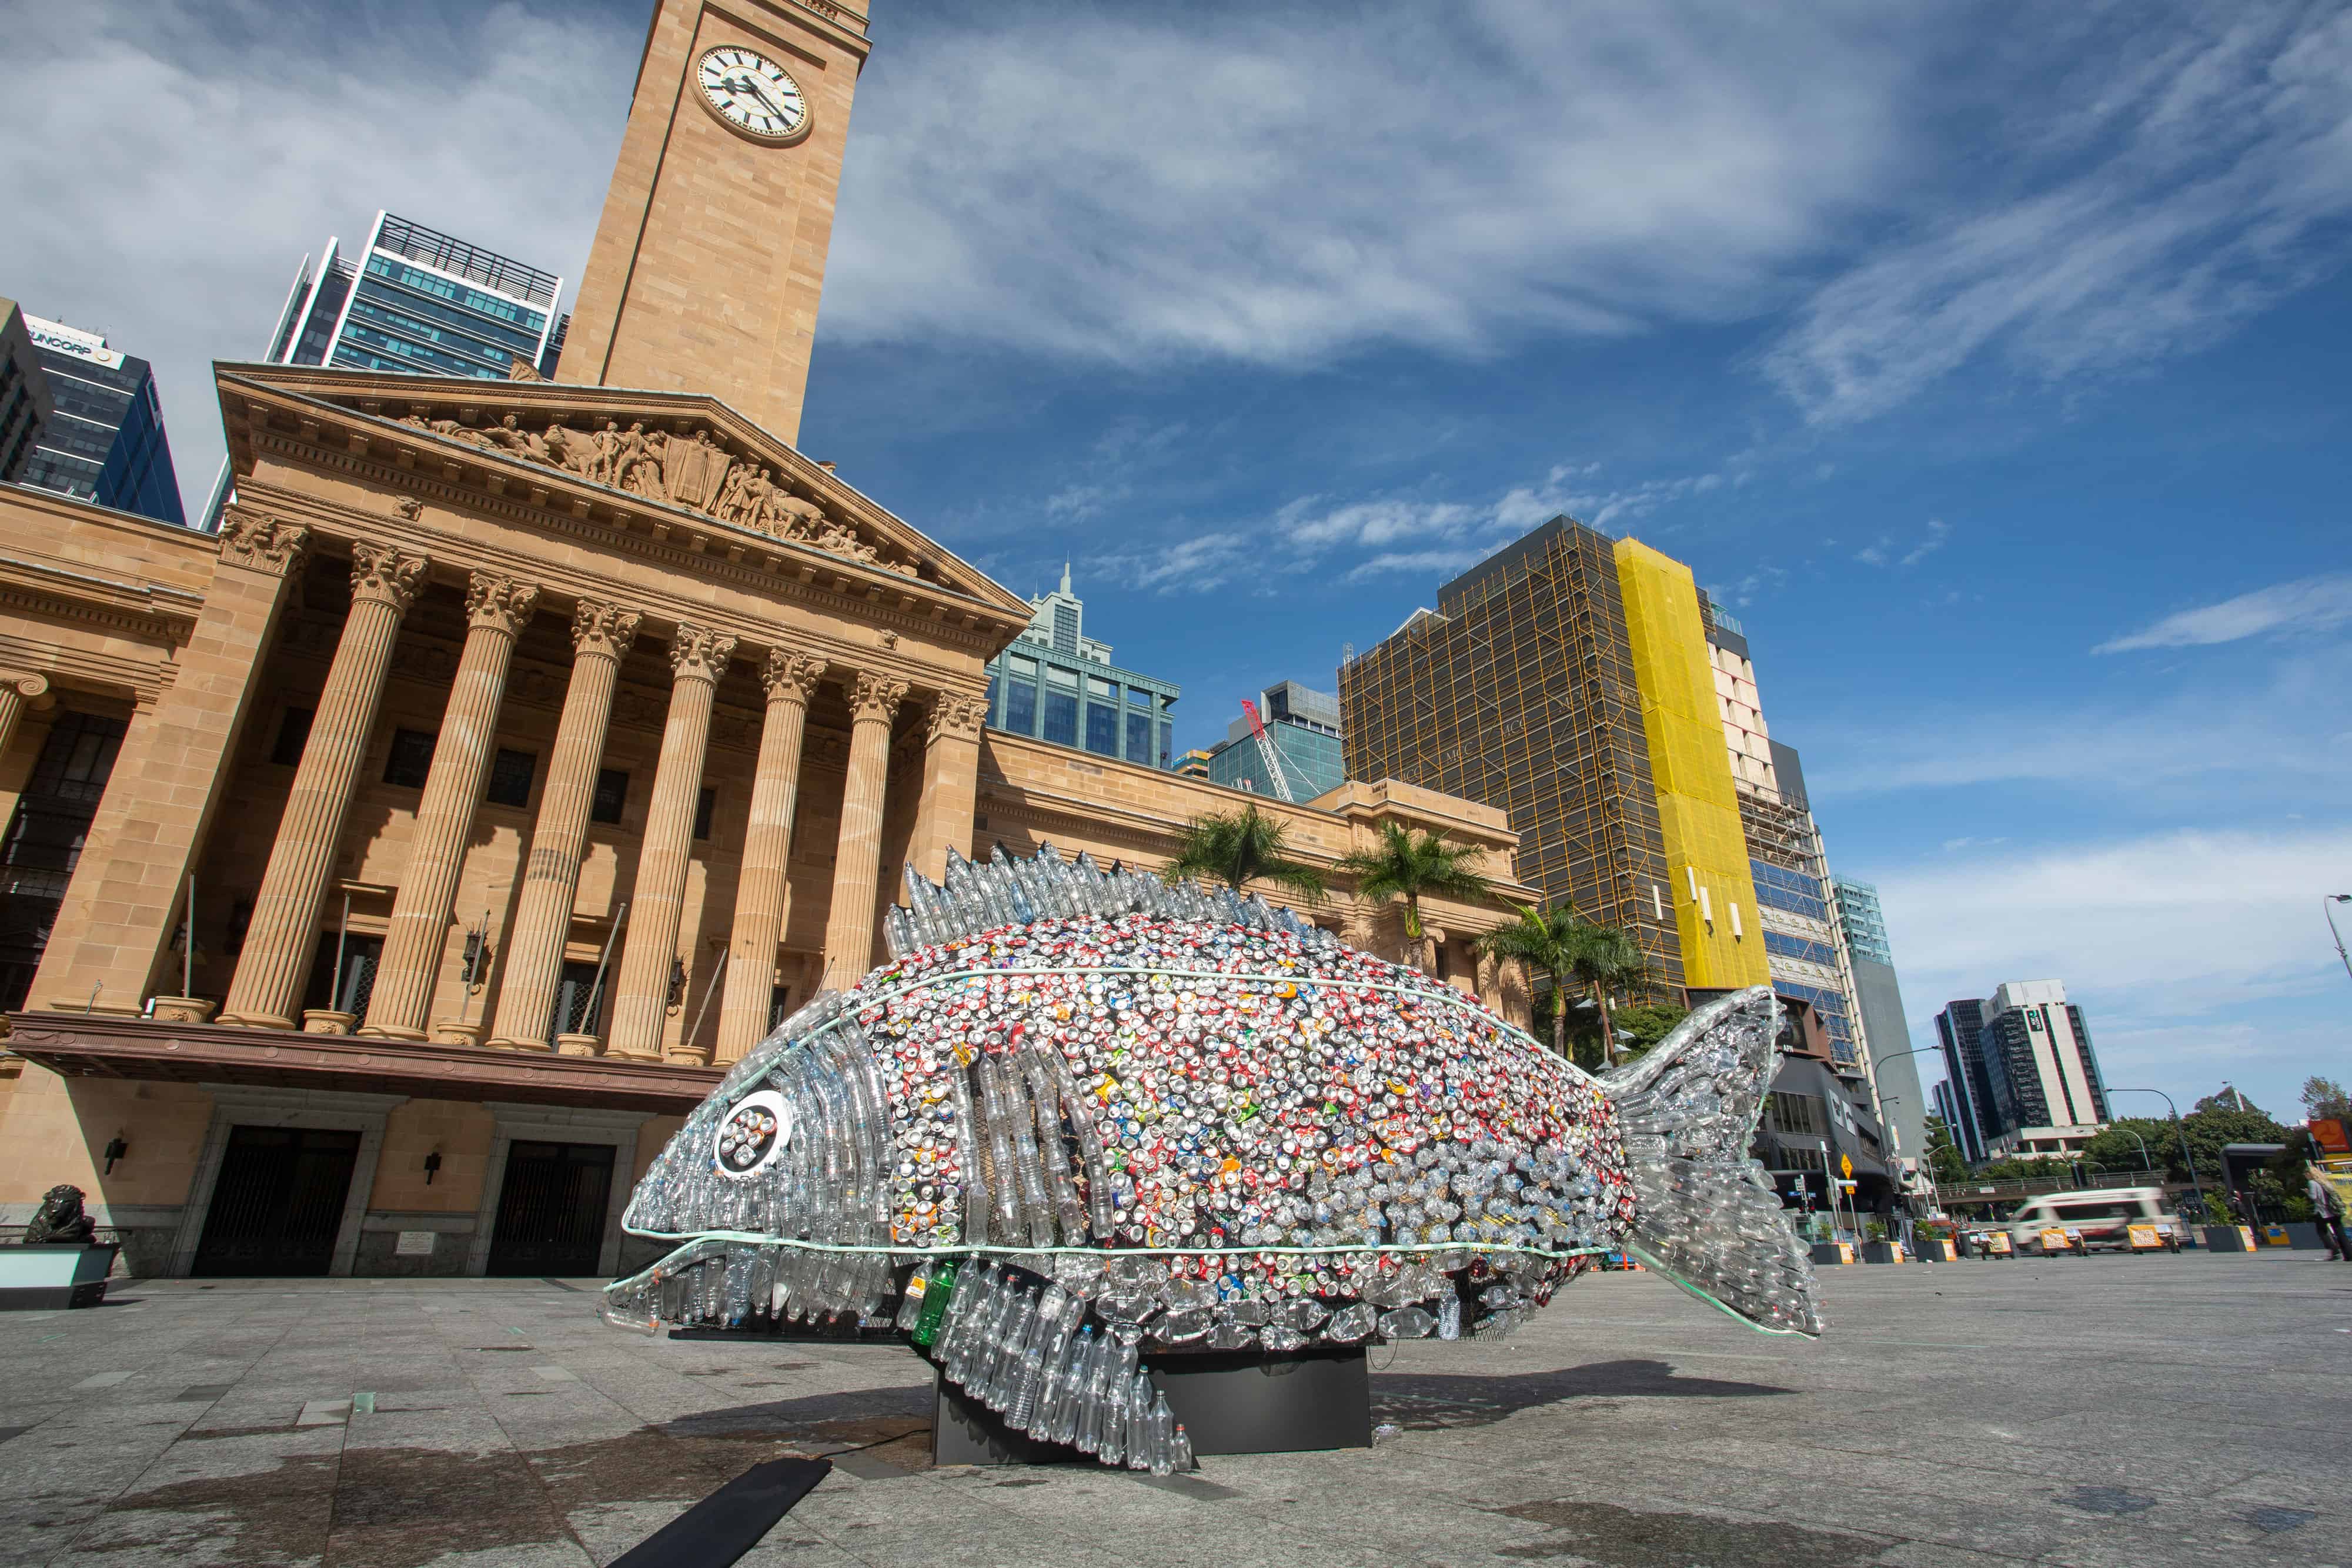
top-left (0, 0), bottom-right (2352, 1128)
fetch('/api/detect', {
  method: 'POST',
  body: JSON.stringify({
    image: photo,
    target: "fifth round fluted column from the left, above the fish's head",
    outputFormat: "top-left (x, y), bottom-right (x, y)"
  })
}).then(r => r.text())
top-left (717, 649), bottom-right (826, 1062)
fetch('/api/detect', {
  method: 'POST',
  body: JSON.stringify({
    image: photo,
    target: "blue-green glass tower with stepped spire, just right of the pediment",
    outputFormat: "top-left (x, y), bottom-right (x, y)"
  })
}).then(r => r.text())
top-left (988, 564), bottom-right (1183, 769)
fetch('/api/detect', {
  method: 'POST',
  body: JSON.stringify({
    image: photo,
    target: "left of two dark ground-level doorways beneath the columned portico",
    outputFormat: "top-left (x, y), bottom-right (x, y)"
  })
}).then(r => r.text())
top-left (193, 1126), bottom-right (360, 1276)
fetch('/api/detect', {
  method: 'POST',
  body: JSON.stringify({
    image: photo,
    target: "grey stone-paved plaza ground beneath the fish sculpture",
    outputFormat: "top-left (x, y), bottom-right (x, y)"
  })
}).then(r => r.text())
top-left (0, 1253), bottom-right (2352, 1568)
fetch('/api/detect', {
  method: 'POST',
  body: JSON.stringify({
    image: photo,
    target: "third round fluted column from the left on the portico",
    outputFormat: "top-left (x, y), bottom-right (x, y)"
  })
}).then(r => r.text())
top-left (489, 600), bottom-right (637, 1051)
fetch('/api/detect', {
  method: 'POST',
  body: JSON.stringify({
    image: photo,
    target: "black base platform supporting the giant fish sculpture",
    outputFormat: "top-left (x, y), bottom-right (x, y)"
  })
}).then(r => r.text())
top-left (931, 1347), bottom-right (1371, 1465)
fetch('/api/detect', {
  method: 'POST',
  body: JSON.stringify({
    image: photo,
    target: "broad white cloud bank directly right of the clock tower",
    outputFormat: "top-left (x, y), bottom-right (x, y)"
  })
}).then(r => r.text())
top-left (823, 0), bottom-right (1910, 367)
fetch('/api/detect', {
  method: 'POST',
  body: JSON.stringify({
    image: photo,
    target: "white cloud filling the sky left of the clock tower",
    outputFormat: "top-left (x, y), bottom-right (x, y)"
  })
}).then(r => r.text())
top-left (0, 0), bottom-right (642, 517)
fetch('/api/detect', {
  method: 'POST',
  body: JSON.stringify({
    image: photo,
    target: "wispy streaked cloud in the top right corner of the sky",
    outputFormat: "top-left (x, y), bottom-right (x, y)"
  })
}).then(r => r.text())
top-left (1764, 2), bottom-right (2352, 423)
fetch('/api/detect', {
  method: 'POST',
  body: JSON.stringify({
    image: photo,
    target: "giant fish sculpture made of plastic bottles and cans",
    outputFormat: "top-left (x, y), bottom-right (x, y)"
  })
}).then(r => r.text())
top-left (602, 846), bottom-right (1823, 1465)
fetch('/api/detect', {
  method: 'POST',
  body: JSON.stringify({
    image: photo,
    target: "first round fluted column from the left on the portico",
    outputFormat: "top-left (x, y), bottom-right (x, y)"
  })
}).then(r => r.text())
top-left (221, 543), bottom-right (426, 1029)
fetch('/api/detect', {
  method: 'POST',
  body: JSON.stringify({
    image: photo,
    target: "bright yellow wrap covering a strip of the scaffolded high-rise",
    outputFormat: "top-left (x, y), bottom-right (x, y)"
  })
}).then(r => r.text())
top-left (1616, 539), bottom-right (1771, 987)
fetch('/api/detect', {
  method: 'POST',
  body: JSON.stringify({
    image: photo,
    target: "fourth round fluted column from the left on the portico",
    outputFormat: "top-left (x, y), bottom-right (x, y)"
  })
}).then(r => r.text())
top-left (612, 626), bottom-right (734, 1058)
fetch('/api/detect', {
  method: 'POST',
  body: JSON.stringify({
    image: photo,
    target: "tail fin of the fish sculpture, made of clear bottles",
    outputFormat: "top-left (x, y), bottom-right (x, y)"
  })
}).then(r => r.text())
top-left (1602, 985), bottom-right (1823, 1335)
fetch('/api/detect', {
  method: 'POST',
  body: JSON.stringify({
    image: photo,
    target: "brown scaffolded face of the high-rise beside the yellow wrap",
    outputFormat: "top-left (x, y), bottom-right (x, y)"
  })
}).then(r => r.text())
top-left (1338, 517), bottom-right (1712, 997)
